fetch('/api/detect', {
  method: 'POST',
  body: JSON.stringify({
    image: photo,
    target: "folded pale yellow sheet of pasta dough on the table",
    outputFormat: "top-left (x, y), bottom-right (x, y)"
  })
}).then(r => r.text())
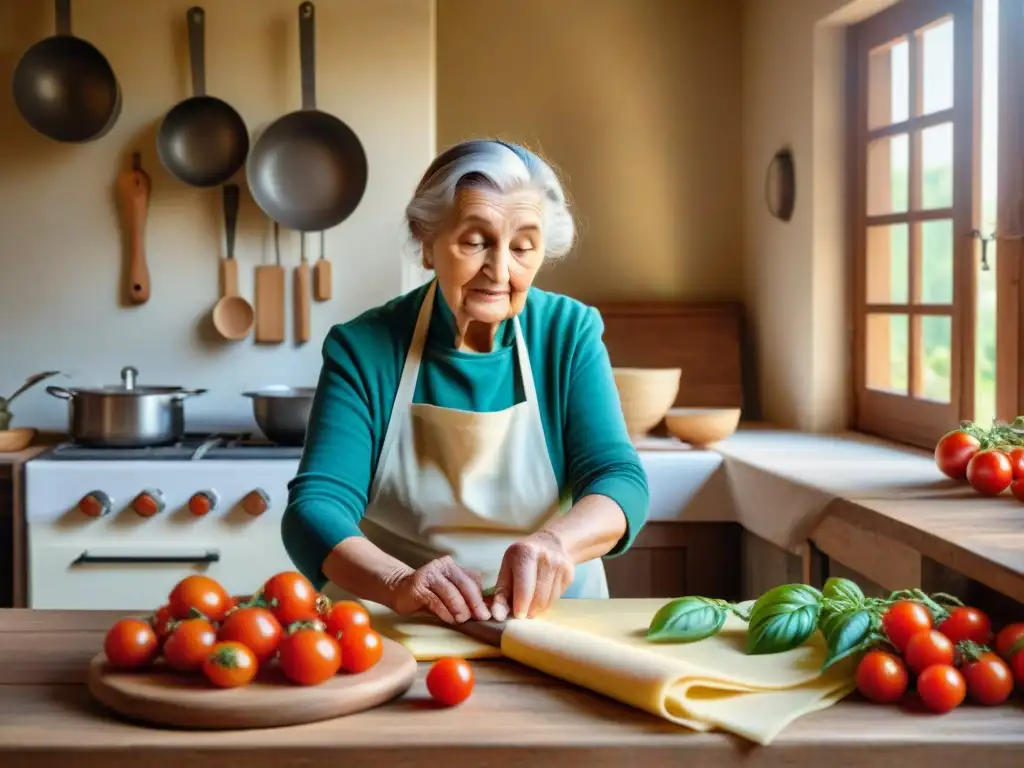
top-left (368, 599), bottom-right (855, 744)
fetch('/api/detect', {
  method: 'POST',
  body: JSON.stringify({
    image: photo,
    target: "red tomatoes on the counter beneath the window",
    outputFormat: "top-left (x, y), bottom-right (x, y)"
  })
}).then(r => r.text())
top-left (935, 425), bottom-right (1024, 502)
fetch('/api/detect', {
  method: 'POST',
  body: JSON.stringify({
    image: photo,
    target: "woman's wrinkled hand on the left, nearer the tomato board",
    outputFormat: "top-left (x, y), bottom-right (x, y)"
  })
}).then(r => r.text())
top-left (391, 556), bottom-right (490, 624)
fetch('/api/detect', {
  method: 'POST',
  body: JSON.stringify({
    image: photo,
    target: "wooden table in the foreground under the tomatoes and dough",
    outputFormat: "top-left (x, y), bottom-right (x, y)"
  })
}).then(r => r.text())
top-left (6, 609), bottom-right (1024, 768)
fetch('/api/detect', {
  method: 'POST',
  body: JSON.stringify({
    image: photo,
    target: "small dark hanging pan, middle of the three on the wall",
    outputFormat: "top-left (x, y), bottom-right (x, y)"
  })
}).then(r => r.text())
top-left (157, 7), bottom-right (249, 186)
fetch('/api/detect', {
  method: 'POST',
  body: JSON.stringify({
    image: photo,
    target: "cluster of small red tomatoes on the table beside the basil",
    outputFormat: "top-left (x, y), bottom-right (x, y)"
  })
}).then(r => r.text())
top-left (856, 600), bottom-right (1024, 713)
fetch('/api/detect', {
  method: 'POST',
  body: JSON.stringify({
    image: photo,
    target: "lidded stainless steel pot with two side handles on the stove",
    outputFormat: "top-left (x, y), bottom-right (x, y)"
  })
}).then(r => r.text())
top-left (46, 366), bottom-right (206, 447)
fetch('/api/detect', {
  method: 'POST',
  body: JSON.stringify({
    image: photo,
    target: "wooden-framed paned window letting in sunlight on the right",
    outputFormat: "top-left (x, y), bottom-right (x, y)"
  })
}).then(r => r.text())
top-left (849, 0), bottom-right (1024, 447)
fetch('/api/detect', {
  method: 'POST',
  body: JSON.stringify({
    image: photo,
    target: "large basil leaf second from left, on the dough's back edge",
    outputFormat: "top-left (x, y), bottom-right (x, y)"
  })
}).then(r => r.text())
top-left (746, 584), bottom-right (821, 655)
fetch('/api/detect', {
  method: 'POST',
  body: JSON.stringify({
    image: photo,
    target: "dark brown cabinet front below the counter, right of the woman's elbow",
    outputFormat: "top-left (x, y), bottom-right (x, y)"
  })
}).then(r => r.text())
top-left (604, 521), bottom-right (743, 600)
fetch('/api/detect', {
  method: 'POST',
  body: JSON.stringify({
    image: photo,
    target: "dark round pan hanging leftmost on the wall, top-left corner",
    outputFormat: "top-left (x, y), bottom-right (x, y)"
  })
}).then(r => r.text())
top-left (14, 0), bottom-right (121, 142)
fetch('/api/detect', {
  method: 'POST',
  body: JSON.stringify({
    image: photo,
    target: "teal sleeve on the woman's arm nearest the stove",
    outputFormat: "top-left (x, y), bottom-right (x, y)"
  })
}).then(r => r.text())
top-left (281, 327), bottom-right (373, 589)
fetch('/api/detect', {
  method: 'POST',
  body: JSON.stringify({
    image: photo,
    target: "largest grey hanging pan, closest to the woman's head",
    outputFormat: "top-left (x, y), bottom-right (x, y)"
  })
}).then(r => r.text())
top-left (246, 2), bottom-right (368, 232)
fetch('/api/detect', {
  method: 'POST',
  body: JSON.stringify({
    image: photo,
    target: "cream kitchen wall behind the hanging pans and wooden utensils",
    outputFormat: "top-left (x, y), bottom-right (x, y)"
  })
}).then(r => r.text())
top-left (0, 0), bottom-right (435, 430)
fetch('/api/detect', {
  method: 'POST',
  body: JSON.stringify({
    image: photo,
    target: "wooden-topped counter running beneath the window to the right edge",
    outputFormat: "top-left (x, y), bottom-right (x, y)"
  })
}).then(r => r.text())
top-left (715, 428), bottom-right (1024, 602)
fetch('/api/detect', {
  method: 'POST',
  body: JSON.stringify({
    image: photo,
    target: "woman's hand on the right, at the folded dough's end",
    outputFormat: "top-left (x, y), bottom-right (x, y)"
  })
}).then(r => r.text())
top-left (490, 530), bottom-right (574, 622)
